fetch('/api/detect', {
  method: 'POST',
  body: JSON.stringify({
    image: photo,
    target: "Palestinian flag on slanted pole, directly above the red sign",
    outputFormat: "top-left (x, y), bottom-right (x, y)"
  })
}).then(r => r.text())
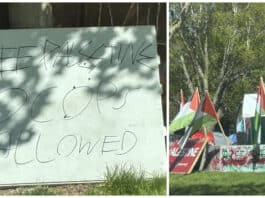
top-left (179, 91), bottom-right (219, 149)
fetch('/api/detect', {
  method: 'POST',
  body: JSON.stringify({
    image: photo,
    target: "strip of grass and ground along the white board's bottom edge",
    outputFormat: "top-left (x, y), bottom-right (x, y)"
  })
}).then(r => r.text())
top-left (0, 166), bottom-right (166, 195)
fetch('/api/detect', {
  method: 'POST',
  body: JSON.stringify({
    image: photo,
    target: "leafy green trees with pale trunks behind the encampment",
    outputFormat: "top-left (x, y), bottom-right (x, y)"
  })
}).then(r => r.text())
top-left (170, 3), bottom-right (265, 130)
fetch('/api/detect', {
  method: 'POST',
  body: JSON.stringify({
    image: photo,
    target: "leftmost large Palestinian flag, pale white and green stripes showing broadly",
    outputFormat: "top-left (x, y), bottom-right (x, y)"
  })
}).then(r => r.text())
top-left (169, 88), bottom-right (200, 133)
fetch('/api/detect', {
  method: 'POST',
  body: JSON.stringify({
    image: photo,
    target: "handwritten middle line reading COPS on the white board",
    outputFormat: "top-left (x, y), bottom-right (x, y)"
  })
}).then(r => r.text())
top-left (0, 82), bottom-right (140, 123)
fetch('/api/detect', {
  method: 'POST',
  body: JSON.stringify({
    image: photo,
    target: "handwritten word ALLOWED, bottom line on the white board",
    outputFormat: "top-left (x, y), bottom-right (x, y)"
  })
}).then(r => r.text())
top-left (0, 131), bottom-right (138, 165)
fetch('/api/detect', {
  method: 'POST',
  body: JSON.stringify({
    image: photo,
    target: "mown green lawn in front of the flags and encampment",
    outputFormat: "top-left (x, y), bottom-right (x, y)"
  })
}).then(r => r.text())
top-left (170, 171), bottom-right (265, 195)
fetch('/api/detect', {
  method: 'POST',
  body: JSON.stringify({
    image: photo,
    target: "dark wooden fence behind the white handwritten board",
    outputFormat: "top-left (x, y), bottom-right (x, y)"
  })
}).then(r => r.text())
top-left (0, 3), bottom-right (167, 123)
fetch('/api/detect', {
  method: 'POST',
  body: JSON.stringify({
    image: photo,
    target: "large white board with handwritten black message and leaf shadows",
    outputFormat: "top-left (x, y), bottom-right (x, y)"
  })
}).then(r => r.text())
top-left (0, 26), bottom-right (166, 185)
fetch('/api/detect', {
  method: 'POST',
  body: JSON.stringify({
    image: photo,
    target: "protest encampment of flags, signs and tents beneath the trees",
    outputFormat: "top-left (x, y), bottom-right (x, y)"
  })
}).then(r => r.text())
top-left (170, 78), bottom-right (265, 174)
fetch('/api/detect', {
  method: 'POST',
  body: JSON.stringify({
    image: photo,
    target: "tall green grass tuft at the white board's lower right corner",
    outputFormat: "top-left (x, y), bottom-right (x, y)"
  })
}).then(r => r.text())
top-left (87, 166), bottom-right (166, 195)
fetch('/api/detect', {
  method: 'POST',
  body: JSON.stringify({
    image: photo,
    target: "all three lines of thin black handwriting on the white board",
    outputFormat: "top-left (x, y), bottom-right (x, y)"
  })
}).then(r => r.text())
top-left (0, 36), bottom-right (153, 165)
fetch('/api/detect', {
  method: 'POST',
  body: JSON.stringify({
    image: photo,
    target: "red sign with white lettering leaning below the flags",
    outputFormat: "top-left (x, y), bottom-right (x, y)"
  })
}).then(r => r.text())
top-left (169, 139), bottom-right (207, 174)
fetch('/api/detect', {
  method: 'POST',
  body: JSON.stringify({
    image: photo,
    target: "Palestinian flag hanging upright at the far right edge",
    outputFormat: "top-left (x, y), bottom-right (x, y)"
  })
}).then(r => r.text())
top-left (252, 78), bottom-right (265, 144)
